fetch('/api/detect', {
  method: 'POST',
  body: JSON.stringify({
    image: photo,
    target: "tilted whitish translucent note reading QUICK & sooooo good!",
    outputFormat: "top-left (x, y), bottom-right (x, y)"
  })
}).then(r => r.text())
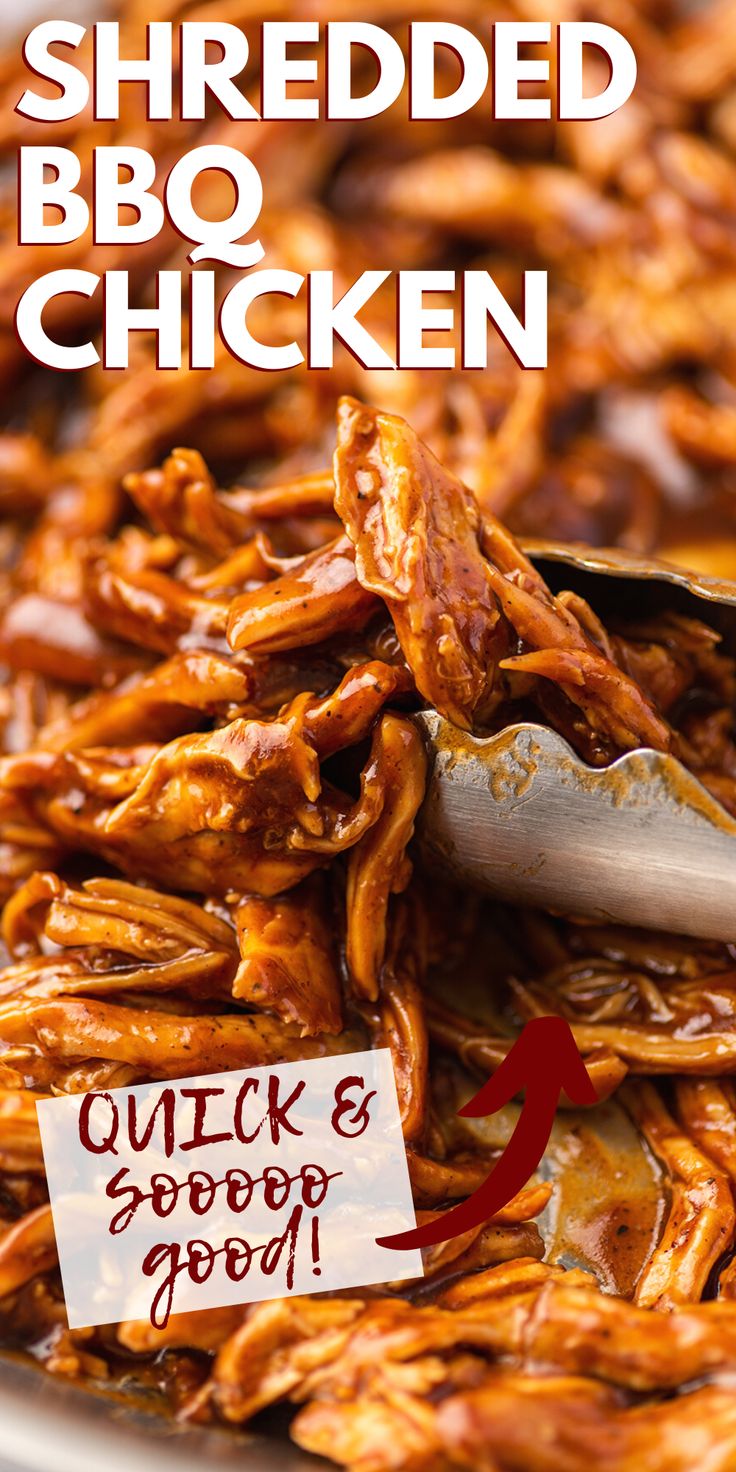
top-left (37, 1048), bottom-right (422, 1329)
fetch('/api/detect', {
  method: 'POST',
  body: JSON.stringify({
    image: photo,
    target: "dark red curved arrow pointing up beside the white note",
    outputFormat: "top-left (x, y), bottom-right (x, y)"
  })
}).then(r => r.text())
top-left (375, 1017), bottom-right (598, 1247)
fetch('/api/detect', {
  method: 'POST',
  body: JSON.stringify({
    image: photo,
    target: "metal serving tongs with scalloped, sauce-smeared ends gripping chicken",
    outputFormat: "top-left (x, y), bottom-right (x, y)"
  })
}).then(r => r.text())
top-left (417, 542), bottom-right (736, 941)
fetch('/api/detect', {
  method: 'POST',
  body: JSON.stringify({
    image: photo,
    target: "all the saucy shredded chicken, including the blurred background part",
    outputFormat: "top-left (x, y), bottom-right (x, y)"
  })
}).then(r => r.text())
top-left (0, 0), bottom-right (736, 1472)
